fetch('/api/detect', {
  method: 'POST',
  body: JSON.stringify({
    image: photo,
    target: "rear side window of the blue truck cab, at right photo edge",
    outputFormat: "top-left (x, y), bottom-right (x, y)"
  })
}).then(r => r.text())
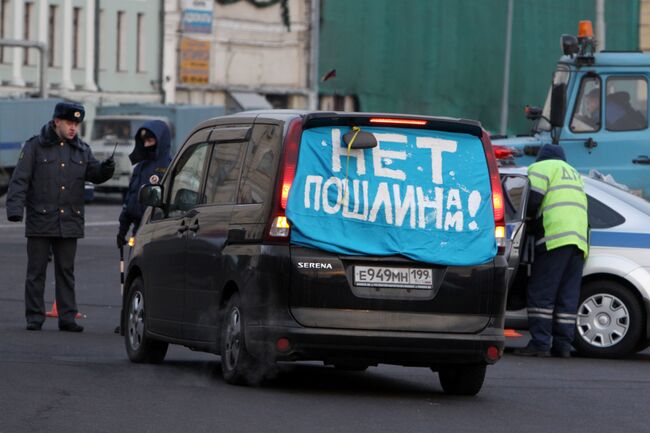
top-left (605, 76), bottom-right (648, 131)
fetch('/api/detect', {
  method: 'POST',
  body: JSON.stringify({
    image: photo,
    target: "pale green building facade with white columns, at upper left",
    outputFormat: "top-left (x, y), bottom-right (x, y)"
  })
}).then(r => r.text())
top-left (0, 0), bottom-right (163, 105)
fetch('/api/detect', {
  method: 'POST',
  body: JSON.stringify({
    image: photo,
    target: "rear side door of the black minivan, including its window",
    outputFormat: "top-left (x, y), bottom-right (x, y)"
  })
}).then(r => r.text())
top-left (183, 125), bottom-right (251, 343)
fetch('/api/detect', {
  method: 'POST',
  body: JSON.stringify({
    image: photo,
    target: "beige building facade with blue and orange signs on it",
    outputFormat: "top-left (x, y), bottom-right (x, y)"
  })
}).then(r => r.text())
top-left (163, 0), bottom-right (314, 109)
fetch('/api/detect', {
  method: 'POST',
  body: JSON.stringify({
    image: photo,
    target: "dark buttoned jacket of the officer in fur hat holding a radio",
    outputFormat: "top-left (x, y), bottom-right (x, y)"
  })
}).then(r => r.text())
top-left (6, 121), bottom-right (113, 238)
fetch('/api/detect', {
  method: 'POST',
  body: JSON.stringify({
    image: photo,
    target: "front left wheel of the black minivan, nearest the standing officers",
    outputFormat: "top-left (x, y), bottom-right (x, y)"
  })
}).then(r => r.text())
top-left (124, 278), bottom-right (169, 364)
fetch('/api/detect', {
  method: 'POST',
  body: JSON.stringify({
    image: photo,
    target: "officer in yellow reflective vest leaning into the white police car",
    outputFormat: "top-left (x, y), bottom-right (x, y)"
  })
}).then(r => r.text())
top-left (514, 144), bottom-right (589, 358)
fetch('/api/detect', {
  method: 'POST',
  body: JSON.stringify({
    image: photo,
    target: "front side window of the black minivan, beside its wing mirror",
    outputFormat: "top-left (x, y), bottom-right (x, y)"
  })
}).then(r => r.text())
top-left (168, 143), bottom-right (209, 217)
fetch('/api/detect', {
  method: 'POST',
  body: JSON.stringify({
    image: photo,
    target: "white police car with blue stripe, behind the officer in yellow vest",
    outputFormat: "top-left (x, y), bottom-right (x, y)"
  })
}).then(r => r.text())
top-left (497, 167), bottom-right (650, 357)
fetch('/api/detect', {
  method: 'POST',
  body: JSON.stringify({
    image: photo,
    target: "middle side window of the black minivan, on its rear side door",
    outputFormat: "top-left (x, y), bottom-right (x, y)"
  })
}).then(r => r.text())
top-left (205, 142), bottom-right (246, 204)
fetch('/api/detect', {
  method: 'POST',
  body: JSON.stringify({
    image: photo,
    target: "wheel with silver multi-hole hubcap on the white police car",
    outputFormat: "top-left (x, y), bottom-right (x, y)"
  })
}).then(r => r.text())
top-left (573, 280), bottom-right (643, 358)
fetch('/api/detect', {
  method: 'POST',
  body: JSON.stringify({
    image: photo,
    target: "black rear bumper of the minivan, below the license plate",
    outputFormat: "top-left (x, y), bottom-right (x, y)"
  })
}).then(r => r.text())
top-left (246, 325), bottom-right (505, 369)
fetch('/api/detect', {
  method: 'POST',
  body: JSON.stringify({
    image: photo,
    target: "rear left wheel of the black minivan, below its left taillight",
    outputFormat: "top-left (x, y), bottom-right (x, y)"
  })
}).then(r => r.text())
top-left (221, 293), bottom-right (265, 385)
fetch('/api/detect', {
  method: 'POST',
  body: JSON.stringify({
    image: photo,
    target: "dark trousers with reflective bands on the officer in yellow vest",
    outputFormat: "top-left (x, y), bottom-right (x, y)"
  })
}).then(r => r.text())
top-left (528, 245), bottom-right (584, 350)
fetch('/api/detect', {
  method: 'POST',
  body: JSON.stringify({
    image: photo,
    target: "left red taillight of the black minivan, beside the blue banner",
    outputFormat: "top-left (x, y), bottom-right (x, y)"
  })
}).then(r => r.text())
top-left (266, 118), bottom-right (302, 241)
